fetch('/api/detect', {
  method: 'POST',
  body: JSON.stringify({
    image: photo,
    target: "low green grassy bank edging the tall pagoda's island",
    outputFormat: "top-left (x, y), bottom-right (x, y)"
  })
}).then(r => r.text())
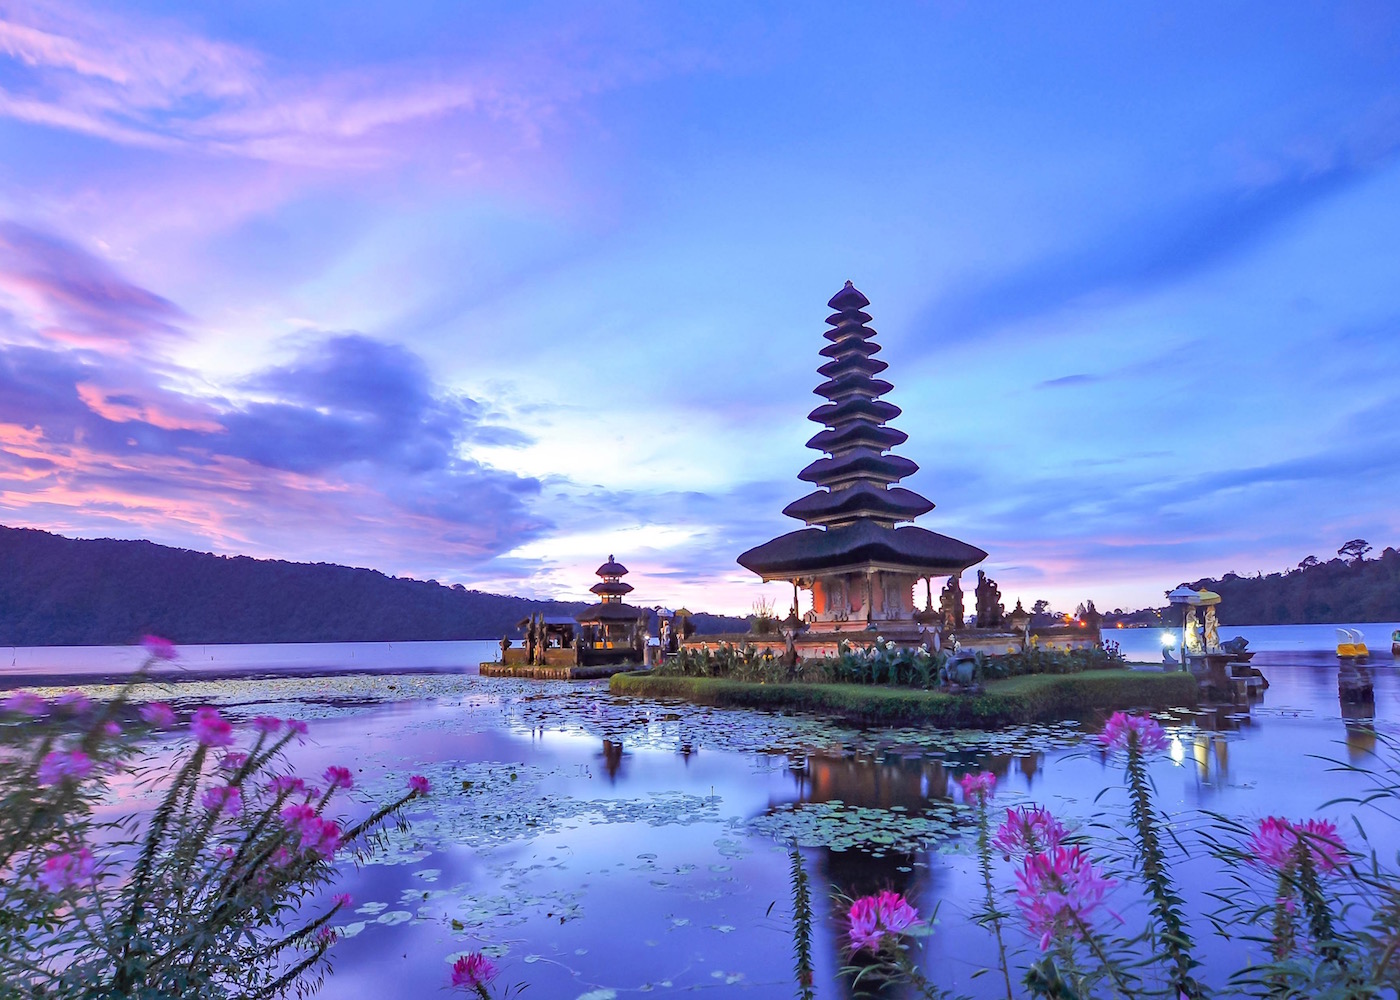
top-left (609, 668), bottom-right (1196, 728)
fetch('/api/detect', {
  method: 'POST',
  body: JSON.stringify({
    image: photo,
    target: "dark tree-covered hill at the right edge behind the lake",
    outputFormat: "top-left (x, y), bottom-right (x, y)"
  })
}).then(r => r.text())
top-left (1191, 539), bottom-right (1400, 625)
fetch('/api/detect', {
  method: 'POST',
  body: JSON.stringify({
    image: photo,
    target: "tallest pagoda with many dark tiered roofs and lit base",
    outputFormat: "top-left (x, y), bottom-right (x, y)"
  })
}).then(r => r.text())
top-left (739, 282), bottom-right (987, 655)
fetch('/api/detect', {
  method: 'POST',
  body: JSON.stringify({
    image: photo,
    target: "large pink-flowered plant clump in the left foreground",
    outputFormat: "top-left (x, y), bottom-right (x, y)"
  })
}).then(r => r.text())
top-left (0, 637), bottom-right (426, 999)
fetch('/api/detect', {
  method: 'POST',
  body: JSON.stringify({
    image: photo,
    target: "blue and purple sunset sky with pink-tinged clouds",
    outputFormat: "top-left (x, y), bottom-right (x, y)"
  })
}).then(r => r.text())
top-left (0, 0), bottom-right (1400, 612)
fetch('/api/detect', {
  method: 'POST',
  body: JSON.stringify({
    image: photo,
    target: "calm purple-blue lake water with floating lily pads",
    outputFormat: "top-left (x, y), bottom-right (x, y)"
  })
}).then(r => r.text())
top-left (8, 625), bottom-right (1400, 1000)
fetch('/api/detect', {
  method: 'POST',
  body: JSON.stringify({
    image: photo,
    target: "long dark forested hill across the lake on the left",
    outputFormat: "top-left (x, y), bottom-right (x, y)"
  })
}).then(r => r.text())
top-left (0, 525), bottom-right (748, 646)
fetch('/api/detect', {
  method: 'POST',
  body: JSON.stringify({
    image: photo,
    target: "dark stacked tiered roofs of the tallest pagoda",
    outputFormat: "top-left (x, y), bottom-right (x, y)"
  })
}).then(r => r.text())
top-left (739, 282), bottom-right (987, 580)
